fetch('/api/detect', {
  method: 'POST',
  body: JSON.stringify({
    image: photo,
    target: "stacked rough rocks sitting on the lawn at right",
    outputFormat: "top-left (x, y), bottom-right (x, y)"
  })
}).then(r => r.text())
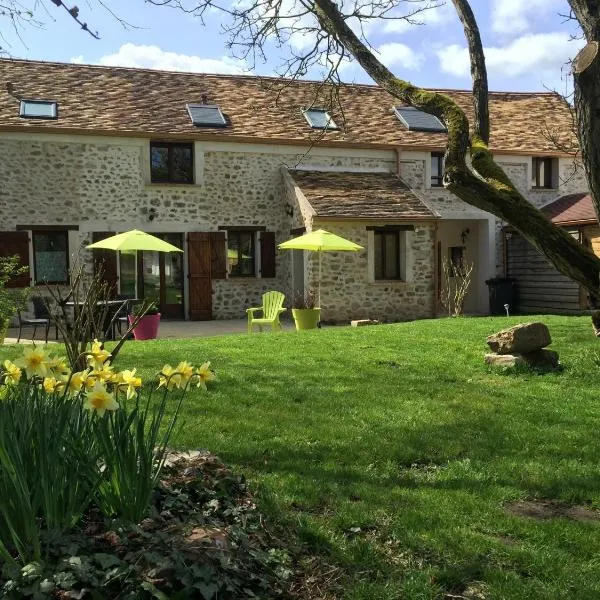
top-left (485, 323), bottom-right (558, 369)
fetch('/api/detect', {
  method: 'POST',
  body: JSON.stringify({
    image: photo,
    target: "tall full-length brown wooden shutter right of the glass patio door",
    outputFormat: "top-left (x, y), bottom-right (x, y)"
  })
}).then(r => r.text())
top-left (188, 233), bottom-right (212, 321)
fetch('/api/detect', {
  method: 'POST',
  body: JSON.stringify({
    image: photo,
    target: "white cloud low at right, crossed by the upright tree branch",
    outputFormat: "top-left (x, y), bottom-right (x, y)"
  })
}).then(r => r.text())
top-left (437, 32), bottom-right (584, 83)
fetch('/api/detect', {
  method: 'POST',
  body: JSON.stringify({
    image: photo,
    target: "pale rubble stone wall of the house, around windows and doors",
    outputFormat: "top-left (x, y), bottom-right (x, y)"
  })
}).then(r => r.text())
top-left (0, 134), bottom-right (585, 320)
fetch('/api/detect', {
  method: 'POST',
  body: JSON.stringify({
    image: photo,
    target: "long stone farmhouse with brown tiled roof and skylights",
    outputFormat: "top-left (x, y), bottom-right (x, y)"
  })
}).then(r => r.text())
top-left (0, 60), bottom-right (586, 321)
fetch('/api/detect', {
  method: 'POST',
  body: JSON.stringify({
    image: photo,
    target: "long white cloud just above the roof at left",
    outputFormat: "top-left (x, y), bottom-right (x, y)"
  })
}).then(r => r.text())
top-left (71, 43), bottom-right (248, 74)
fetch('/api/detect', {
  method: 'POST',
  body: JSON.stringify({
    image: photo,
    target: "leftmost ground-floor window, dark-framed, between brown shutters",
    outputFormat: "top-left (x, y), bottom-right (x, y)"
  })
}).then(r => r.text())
top-left (33, 231), bottom-right (69, 285)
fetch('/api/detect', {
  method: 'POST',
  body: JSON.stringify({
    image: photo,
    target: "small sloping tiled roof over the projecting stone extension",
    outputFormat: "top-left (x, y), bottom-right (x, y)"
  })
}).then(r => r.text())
top-left (290, 170), bottom-right (437, 221)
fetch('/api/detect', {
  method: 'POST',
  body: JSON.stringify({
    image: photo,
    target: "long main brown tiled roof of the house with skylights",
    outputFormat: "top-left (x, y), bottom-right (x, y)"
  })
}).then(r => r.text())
top-left (0, 59), bottom-right (571, 154)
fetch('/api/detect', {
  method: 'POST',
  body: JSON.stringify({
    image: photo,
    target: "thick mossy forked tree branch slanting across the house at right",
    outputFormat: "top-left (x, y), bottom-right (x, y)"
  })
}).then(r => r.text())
top-left (314, 0), bottom-right (600, 297)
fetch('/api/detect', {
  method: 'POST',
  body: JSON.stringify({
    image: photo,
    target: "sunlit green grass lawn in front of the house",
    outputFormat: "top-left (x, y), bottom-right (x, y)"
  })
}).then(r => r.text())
top-left (0, 317), bottom-right (600, 600)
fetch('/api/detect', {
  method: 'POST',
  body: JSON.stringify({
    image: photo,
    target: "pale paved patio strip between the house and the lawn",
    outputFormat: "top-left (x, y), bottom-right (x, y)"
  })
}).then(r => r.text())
top-left (4, 319), bottom-right (295, 344)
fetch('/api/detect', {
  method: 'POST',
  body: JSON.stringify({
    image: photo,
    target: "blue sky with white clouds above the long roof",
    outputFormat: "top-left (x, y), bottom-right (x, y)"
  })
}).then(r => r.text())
top-left (0, 0), bottom-right (582, 92)
